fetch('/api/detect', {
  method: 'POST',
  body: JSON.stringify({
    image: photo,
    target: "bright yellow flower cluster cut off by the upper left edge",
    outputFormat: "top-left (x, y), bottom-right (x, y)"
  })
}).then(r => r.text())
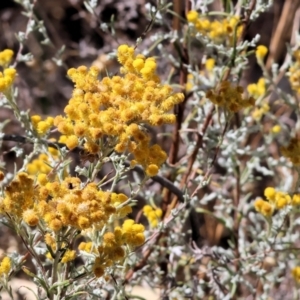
top-left (0, 49), bottom-right (16, 93)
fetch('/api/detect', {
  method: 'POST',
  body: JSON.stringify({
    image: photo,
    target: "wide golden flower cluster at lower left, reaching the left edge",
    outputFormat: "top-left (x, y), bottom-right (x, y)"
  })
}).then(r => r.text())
top-left (0, 173), bottom-right (131, 232)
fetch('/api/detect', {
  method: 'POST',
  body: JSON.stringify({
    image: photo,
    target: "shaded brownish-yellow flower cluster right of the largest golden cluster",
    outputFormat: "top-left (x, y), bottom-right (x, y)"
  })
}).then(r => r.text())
top-left (206, 81), bottom-right (255, 112)
